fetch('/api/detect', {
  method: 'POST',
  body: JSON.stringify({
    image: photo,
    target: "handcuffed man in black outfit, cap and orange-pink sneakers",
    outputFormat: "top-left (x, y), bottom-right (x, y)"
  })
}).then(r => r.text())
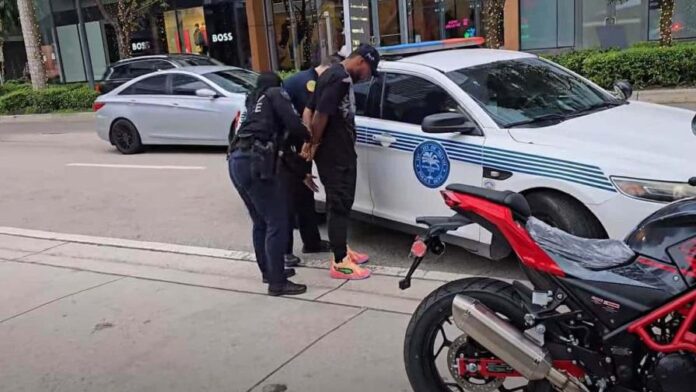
top-left (303, 44), bottom-right (379, 279)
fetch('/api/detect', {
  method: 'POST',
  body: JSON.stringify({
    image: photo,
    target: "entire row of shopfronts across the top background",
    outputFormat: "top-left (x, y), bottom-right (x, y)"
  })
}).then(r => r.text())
top-left (23, 0), bottom-right (696, 82)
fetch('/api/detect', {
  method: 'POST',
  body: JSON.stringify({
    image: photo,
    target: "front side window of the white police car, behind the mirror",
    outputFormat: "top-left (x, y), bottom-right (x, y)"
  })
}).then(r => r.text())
top-left (382, 73), bottom-right (461, 125)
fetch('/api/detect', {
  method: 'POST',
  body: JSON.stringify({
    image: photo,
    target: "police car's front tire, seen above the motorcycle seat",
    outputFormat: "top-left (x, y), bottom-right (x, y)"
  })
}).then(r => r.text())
top-left (526, 191), bottom-right (608, 238)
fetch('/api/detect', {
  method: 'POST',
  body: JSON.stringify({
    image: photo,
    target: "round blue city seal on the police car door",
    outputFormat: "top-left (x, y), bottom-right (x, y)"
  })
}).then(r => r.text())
top-left (413, 141), bottom-right (450, 188)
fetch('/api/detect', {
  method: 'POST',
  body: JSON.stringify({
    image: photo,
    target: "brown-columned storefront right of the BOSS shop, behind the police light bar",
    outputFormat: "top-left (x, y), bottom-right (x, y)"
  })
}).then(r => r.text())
top-left (265, 0), bottom-right (483, 70)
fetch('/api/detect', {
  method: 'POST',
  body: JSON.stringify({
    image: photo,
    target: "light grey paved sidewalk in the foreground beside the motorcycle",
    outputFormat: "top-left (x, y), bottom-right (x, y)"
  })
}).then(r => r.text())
top-left (0, 228), bottom-right (476, 392)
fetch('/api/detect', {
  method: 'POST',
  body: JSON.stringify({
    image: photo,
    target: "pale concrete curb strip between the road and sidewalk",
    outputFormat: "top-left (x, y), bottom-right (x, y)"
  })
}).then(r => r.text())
top-left (0, 226), bottom-right (474, 281)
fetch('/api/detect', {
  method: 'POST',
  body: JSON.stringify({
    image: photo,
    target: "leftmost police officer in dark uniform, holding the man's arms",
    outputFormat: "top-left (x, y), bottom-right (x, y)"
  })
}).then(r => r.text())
top-left (228, 72), bottom-right (309, 296)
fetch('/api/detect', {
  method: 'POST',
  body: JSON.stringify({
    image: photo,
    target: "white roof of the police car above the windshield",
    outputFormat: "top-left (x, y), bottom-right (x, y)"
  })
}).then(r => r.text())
top-left (397, 49), bottom-right (537, 72)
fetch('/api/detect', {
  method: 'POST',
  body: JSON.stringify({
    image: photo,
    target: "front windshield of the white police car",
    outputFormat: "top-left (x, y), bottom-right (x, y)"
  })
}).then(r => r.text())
top-left (447, 58), bottom-right (621, 128)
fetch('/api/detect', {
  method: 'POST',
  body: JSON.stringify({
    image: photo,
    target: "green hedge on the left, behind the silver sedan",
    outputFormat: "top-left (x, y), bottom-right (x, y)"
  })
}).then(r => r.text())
top-left (0, 85), bottom-right (99, 114)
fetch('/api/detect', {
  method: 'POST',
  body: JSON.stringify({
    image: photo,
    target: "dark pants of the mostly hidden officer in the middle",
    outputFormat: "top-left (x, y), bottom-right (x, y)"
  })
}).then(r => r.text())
top-left (283, 163), bottom-right (321, 254)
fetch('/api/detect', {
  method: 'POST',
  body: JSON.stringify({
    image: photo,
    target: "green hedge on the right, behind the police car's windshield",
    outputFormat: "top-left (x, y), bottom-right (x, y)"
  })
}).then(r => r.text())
top-left (549, 42), bottom-right (696, 89)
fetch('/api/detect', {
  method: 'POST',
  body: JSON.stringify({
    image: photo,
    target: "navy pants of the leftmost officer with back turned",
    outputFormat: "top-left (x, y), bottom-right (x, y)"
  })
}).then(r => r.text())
top-left (229, 150), bottom-right (288, 287)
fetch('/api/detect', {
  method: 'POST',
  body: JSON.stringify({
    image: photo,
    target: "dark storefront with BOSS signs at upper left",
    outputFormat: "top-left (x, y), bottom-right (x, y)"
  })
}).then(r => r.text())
top-left (37, 0), bottom-right (252, 83)
